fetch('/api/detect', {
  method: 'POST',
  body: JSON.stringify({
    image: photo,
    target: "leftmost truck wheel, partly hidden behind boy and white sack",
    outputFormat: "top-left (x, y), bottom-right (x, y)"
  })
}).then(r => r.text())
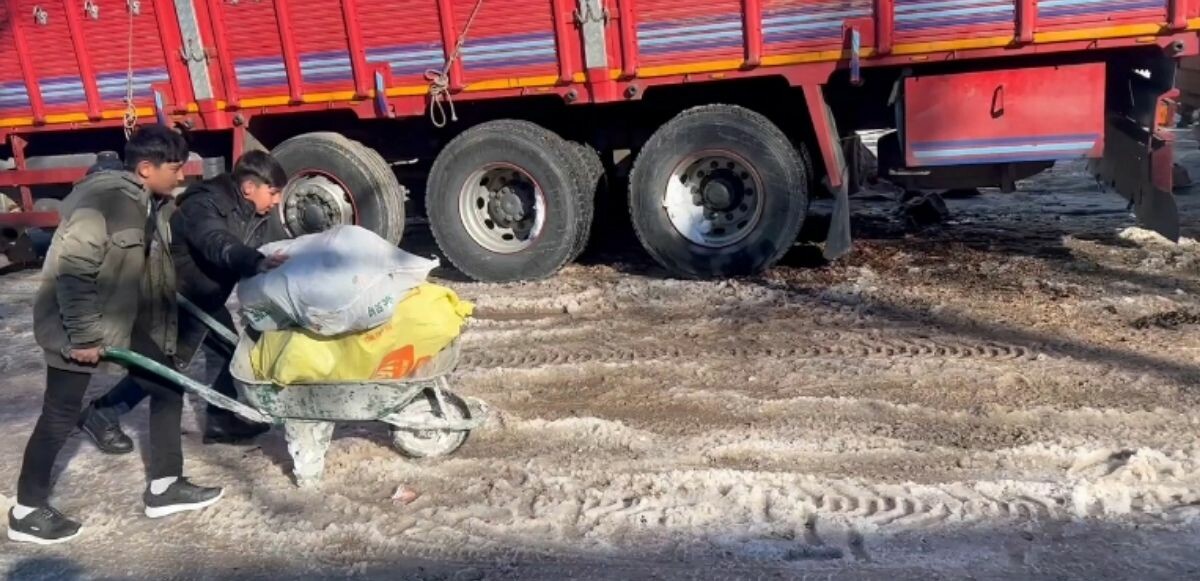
top-left (271, 132), bottom-right (407, 244)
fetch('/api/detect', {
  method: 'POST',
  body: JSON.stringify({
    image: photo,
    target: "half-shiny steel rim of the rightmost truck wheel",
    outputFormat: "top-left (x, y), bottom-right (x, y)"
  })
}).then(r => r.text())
top-left (662, 150), bottom-right (764, 248)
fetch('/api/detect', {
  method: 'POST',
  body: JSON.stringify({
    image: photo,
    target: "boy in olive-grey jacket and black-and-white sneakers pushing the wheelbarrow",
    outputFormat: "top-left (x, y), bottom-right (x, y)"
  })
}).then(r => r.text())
top-left (8, 125), bottom-right (223, 545)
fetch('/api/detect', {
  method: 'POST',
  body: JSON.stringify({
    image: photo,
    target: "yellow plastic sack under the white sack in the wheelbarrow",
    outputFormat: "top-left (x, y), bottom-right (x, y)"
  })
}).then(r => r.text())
top-left (250, 283), bottom-right (474, 385)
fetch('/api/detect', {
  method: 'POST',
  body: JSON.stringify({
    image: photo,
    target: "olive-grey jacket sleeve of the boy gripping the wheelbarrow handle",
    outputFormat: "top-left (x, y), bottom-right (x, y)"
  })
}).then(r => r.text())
top-left (55, 208), bottom-right (108, 348)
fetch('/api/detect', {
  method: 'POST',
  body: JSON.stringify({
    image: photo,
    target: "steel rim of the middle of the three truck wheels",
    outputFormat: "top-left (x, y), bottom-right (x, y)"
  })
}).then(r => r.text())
top-left (458, 163), bottom-right (546, 254)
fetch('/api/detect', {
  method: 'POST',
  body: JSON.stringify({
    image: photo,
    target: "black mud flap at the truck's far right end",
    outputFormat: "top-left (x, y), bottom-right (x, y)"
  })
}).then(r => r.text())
top-left (1092, 116), bottom-right (1180, 242)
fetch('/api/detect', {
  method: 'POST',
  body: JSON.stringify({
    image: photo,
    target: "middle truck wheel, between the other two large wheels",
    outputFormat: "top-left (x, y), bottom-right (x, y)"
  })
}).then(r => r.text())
top-left (426, 120), bottom-right (589, 282)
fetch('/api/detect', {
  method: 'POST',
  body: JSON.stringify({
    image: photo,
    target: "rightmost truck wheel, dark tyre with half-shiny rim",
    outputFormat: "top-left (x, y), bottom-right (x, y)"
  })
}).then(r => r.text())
top-left (629, 106), bottom-right (809, 278)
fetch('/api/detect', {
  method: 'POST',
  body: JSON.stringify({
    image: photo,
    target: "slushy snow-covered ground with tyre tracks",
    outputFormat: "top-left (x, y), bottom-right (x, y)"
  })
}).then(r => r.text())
top-left (0, 138), bottom-right (1200, 580)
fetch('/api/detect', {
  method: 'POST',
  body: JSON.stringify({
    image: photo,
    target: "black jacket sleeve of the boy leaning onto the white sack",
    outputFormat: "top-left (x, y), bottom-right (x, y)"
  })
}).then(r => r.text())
top-left (174, 199), bottom-right (264, 278)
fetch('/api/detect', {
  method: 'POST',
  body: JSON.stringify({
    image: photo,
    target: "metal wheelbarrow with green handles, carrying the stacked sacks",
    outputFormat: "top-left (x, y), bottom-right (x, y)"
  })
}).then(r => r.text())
top-left (104, 297), bottom-right (488, 487)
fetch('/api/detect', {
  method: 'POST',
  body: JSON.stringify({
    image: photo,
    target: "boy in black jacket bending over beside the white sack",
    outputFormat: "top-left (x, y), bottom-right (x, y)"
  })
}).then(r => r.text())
top-left (79, 151), bottom-right (287, 454)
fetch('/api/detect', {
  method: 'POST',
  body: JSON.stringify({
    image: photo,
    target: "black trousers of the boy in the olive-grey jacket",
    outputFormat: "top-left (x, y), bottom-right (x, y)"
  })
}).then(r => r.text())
top-left (17, 335), bottom-right (184, 507)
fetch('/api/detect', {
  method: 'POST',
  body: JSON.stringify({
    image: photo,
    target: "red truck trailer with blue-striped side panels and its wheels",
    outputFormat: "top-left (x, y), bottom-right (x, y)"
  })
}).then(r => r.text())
top-left (0, 0), bottom-right (1200, 281)
